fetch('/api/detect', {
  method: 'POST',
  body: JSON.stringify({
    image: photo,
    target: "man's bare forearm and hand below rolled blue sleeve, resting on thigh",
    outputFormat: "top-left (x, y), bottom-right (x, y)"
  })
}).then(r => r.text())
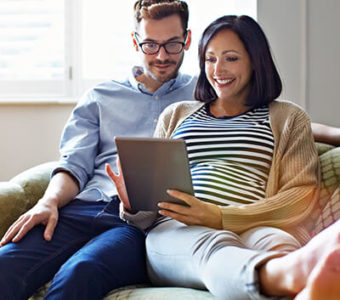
top-left (0, 171), bottom-right (79, 246)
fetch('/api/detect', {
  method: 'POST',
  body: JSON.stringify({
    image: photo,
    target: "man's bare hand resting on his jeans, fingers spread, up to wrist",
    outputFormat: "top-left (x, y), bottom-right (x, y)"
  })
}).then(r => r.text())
top-left (0, 199), bottom-right (58, 246)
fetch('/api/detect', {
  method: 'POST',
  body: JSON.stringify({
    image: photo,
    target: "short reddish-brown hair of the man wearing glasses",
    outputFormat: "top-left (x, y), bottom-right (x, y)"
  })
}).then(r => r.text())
top-left (134, 0), bottom-right (189, 34)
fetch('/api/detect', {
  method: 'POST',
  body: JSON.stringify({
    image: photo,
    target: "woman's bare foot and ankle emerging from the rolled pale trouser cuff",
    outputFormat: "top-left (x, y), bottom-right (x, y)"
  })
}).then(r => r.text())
top-left (259, 220), bottom-right (340, 300)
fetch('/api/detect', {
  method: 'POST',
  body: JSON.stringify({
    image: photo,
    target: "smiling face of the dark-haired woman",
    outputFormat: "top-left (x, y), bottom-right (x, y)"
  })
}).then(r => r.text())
top-left (205, 29), bottom-right (252, 104)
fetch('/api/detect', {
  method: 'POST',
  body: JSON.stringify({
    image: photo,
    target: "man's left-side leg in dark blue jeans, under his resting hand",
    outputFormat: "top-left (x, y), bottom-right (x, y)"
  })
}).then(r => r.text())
top-left (0, 200), bottom-right (106, 300)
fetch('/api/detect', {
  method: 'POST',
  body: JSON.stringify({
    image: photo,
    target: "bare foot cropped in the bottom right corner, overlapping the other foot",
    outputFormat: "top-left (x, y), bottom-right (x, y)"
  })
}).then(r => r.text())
top-left (294, 247), bottom-right (340, 300)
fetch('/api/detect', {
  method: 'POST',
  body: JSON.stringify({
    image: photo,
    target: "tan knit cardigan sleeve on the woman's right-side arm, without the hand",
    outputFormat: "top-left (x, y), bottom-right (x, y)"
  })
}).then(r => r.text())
top-left (221, 111), bottom-right (320, 233)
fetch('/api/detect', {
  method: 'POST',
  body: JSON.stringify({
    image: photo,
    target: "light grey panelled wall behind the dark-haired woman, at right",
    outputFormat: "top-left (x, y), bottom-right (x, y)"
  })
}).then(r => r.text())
top-left (258, 0), bottom-right (340, 126)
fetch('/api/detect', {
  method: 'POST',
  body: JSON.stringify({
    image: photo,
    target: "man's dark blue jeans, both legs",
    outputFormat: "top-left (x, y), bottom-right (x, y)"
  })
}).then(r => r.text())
top-left (0, 198), bottom-right (148, 300)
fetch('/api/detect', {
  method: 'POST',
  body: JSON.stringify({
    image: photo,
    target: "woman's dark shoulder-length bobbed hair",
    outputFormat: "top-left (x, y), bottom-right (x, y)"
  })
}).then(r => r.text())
top-left (195, 16), bottom-right (282, 107)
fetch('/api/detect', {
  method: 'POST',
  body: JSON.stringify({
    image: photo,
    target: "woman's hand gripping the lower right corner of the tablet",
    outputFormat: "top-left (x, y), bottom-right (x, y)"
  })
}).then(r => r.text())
top-left (158, 190), bottom-right (222, 229)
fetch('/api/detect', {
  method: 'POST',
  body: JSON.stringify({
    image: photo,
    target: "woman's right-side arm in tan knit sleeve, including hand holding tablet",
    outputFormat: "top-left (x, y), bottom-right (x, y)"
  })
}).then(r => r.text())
top-left (160, 106), bottom-right (319, 238)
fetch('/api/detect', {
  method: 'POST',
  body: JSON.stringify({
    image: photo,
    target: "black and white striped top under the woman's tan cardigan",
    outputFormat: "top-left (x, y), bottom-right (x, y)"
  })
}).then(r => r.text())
top-left (172, 105), bottom-right (274, 205)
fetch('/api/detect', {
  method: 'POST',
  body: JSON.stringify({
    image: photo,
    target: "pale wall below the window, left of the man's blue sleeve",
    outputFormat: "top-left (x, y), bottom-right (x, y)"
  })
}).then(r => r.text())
top-left (0, 104), bottom-right (73, 181)
